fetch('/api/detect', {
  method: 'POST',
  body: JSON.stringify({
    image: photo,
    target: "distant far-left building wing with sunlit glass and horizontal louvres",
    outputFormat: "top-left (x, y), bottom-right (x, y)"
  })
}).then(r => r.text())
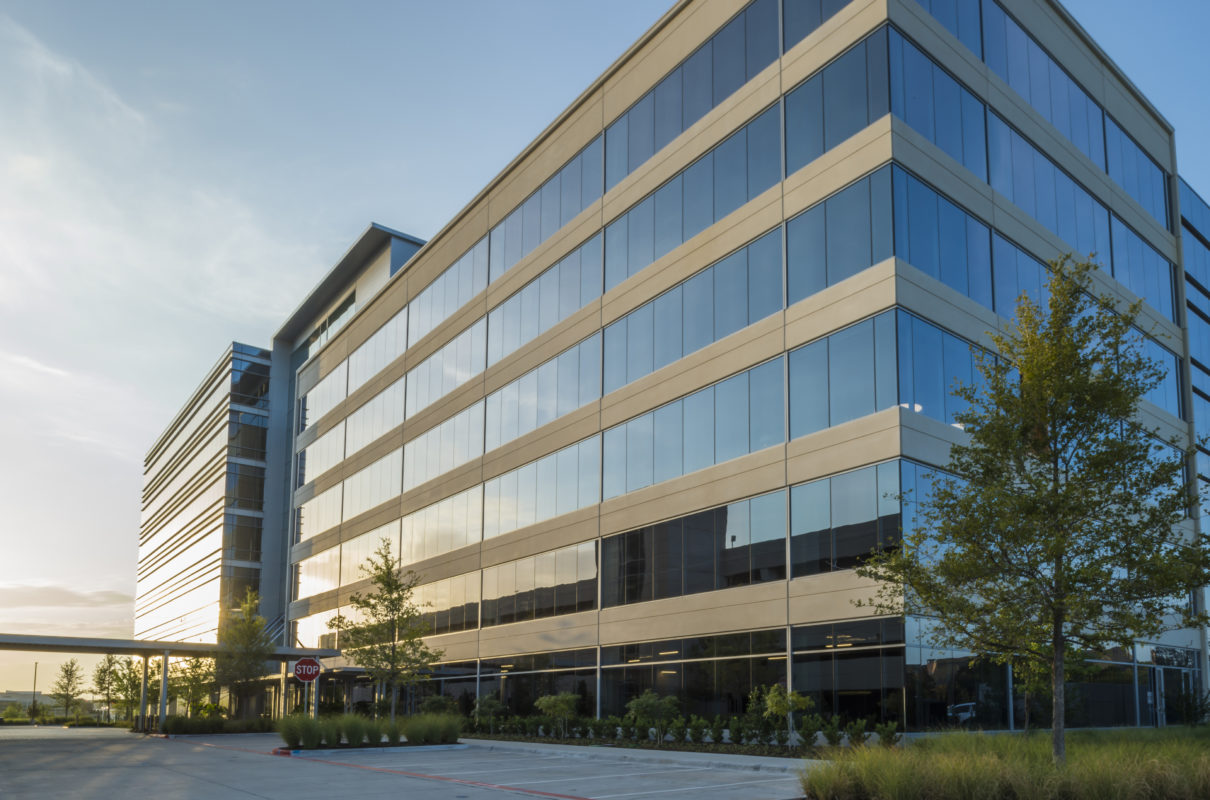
top-left (134, 343), bottom-right (277, 641)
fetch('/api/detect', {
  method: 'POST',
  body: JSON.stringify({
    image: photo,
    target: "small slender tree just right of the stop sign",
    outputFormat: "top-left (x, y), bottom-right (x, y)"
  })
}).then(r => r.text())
top-left (328, 539), bottom-right (442, 721)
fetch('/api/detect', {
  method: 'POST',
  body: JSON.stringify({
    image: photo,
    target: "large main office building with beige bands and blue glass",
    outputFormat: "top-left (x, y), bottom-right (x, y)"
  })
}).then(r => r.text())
top-left (140, 0), bottom-right (1210, 730)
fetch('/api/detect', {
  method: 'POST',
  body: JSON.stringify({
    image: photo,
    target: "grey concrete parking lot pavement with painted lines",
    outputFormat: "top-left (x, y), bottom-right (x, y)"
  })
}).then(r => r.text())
top-left (0, 727), bottom-right (803, 800)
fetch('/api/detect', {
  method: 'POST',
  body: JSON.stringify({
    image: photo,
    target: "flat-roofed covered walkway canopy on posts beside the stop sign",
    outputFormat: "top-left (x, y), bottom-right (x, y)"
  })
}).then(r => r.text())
top-left (0, 633), bottom-right (340, 733)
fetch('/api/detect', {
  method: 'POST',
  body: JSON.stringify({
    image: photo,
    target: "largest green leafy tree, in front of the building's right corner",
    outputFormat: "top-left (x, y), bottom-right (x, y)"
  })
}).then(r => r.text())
top-left (858, 258), bottom-right (1210, 764)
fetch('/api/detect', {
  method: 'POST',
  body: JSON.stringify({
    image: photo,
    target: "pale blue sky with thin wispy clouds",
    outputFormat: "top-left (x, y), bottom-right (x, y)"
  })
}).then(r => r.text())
top-left (0, 0), bottom-right (1210, 690)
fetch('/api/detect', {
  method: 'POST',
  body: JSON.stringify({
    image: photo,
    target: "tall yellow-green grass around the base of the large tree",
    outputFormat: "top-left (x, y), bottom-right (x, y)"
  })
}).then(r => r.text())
top-left (802, 727), bottom-right (1210, 800)
